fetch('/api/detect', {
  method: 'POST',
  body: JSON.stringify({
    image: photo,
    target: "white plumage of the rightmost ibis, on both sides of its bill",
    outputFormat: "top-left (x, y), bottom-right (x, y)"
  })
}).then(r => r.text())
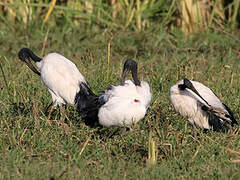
top-left (170, 80), bottom-right (229, 129)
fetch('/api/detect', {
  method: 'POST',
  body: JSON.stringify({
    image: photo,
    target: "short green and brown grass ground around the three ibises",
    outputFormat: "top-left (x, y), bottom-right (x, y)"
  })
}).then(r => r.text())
top-left (0, 23), bottom-right (240, 179)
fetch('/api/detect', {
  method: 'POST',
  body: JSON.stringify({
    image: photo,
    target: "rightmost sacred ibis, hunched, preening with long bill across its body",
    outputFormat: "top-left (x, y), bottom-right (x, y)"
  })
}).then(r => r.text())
top-left (170, 78), bottom-right (238, 133)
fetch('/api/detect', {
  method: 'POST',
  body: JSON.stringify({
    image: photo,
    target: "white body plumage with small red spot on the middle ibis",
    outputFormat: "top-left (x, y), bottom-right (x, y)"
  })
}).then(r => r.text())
top-left (98, 80), bottom-right (152, 127)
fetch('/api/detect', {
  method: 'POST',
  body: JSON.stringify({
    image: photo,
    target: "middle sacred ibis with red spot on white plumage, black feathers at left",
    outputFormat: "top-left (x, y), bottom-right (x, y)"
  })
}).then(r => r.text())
top-left (76, 60), bottom-right (152, 127)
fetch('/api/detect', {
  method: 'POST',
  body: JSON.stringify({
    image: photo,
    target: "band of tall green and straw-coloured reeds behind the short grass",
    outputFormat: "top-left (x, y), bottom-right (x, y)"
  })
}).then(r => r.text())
top-left (0, 0), bottom-right (240, 33)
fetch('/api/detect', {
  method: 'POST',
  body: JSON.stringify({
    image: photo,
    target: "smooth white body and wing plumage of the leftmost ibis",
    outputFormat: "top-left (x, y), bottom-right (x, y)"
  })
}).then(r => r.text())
top-left (41, 53), bottom-right (86, 104)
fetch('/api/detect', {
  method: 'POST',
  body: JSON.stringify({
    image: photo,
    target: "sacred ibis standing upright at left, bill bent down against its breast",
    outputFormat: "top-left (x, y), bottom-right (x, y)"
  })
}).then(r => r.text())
top-left (18, 48), bottom-right (89, 107)
